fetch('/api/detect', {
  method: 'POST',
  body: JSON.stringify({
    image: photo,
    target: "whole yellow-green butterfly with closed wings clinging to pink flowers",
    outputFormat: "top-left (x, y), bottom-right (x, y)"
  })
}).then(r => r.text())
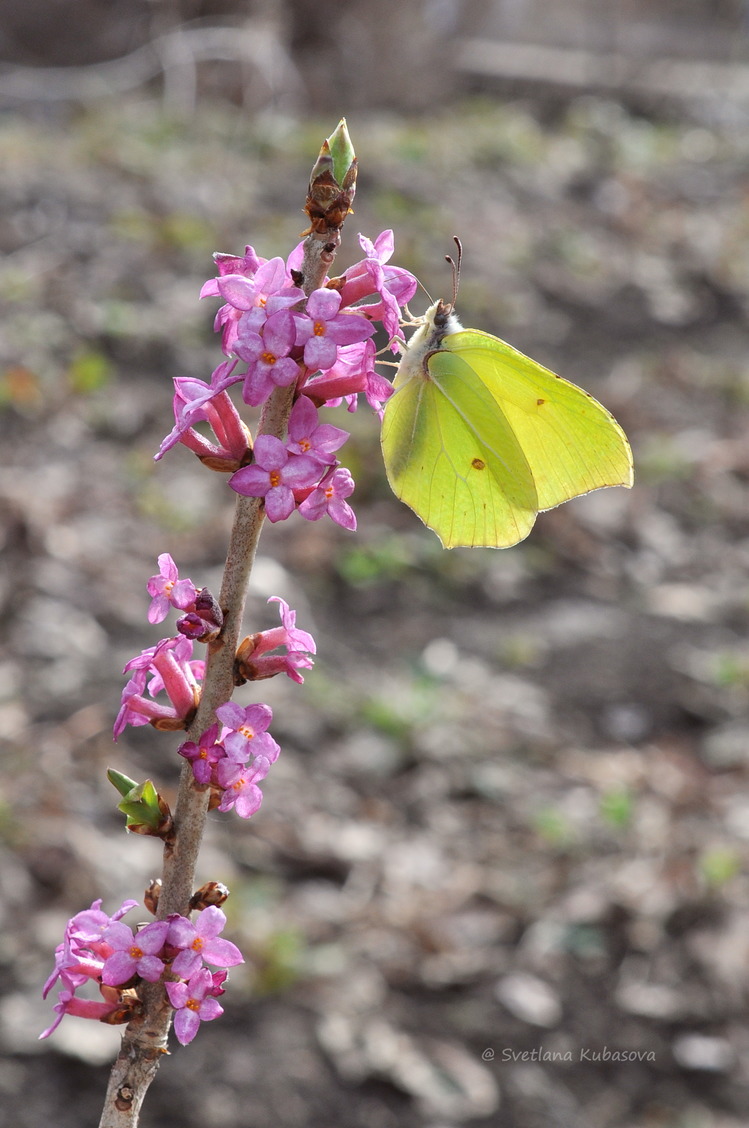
top-left (381, 284), bottom-right (633, 548)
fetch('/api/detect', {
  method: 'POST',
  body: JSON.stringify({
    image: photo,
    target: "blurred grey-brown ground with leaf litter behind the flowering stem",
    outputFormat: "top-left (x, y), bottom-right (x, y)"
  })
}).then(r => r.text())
top-left (0, 0), bottom-right (749, 1128)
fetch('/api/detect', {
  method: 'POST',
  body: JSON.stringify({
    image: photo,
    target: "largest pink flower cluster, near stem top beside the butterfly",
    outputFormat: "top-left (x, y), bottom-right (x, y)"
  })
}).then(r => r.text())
top-left (157, 231), bottom-right (417, 530)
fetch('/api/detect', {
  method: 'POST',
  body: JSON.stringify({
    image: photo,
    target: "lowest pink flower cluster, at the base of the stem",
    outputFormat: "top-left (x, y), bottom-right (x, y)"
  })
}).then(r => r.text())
top-left (39, 900), bottom-right (244, 1046)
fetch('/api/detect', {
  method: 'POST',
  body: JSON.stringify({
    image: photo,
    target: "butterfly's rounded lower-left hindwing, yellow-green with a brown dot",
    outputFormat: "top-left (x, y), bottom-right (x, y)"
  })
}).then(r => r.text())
top-left (382, 347), bottom-right (539, 548)
